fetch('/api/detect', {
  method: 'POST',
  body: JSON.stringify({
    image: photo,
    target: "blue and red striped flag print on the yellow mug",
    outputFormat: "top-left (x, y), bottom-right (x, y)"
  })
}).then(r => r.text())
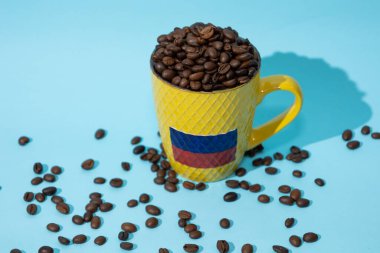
top-left (170, 128), bottom-right (237, 168)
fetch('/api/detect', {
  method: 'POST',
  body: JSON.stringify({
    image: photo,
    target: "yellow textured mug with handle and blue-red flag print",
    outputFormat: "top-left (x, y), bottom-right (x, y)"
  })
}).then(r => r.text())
top-left (152, 63), bottom-right (302, 182)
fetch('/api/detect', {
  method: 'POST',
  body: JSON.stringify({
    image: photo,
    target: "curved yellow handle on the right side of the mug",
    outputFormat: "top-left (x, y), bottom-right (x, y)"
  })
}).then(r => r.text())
top-left (248, 75), bottom-right (302, 149)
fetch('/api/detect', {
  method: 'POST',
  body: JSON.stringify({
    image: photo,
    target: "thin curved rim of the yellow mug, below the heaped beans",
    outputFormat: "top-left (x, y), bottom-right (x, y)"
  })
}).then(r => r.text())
top-left (149, 45), bottom-right (261, 94)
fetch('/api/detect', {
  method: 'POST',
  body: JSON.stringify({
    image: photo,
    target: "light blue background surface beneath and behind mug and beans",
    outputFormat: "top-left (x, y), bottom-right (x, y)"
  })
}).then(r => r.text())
top-left (0, 0), bottom-right (380, 253)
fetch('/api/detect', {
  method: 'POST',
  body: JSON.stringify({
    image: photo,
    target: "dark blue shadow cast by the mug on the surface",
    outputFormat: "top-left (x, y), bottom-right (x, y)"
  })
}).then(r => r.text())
top-left (254, 53), bottom-right (371, 151)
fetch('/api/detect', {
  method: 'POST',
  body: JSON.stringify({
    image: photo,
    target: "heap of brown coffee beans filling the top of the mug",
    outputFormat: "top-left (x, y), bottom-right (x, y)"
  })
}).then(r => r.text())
top-left (151, 22), bottom-right (260, 91)
